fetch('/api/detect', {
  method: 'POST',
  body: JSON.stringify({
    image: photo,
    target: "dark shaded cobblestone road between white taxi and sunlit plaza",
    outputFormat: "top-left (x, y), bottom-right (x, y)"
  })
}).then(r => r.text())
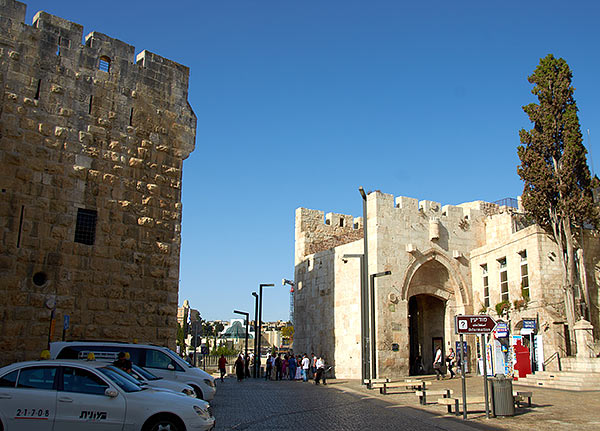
top-left (211, 378), bottom-right (499, 431)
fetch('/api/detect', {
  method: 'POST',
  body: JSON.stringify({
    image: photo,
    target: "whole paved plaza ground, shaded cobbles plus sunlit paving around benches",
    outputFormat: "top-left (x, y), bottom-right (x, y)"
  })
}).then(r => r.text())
top-left (211, 377), bottom-right (600, 431)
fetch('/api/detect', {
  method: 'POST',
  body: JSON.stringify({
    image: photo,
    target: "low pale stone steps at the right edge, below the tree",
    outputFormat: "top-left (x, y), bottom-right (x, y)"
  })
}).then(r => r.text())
top-left (513, 371), bottom-right (600, 391)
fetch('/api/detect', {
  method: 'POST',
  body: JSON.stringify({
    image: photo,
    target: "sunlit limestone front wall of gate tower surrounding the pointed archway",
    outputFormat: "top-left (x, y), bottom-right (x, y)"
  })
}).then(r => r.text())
top-left (367, 192), bottom-right (484, 376)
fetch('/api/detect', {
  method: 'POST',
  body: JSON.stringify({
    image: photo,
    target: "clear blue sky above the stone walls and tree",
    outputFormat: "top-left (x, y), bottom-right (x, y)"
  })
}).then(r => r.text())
top-left (27, 0), bottom-right (600, 320)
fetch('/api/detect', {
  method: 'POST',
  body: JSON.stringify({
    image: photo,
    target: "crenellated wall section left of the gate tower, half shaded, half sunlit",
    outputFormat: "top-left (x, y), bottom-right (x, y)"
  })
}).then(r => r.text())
top-left (294, 208), bottom-right (363, 378)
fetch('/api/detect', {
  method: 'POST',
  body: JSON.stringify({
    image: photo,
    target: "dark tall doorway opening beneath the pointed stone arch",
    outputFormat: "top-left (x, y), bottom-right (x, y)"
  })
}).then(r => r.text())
top-left (408, 295), bottom-right (446, 375)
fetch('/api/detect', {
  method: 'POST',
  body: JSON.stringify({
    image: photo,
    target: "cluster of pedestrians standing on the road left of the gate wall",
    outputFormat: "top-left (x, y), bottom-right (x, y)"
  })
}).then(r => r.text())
top-left (265, 353), bottom-right (327, 385)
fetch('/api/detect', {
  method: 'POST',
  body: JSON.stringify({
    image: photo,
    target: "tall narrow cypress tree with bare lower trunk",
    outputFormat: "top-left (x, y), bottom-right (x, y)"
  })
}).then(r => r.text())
top-left (517, 54), bottom-right (598, 346)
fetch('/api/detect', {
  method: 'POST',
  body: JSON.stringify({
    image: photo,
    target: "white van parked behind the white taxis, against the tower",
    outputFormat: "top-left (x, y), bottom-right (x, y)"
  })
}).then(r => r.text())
top-left (50, 341), bottom-right (216, 401)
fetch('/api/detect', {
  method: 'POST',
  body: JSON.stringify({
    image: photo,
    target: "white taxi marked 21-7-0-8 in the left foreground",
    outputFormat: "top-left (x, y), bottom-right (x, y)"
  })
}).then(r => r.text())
top-left (0, 360), bottom-right (215, 431)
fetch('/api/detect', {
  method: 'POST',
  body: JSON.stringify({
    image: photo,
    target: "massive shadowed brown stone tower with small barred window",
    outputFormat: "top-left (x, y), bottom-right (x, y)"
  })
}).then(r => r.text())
top-left (0, 0), bottom-right (196, 365)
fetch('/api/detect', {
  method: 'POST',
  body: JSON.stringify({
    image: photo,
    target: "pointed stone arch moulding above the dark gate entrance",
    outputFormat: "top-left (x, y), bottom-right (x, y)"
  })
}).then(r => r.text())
top-left (400, 250), bottom-right (470, 306)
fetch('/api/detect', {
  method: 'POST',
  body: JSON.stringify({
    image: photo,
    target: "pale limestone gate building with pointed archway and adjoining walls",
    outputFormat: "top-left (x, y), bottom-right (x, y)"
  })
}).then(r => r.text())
top-left (294, 191), bottom-right (600, 378)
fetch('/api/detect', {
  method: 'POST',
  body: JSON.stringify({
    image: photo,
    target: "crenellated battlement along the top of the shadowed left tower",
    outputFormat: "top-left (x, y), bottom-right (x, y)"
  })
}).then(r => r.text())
top-left (0, 0), bottom-right (189, 120)
